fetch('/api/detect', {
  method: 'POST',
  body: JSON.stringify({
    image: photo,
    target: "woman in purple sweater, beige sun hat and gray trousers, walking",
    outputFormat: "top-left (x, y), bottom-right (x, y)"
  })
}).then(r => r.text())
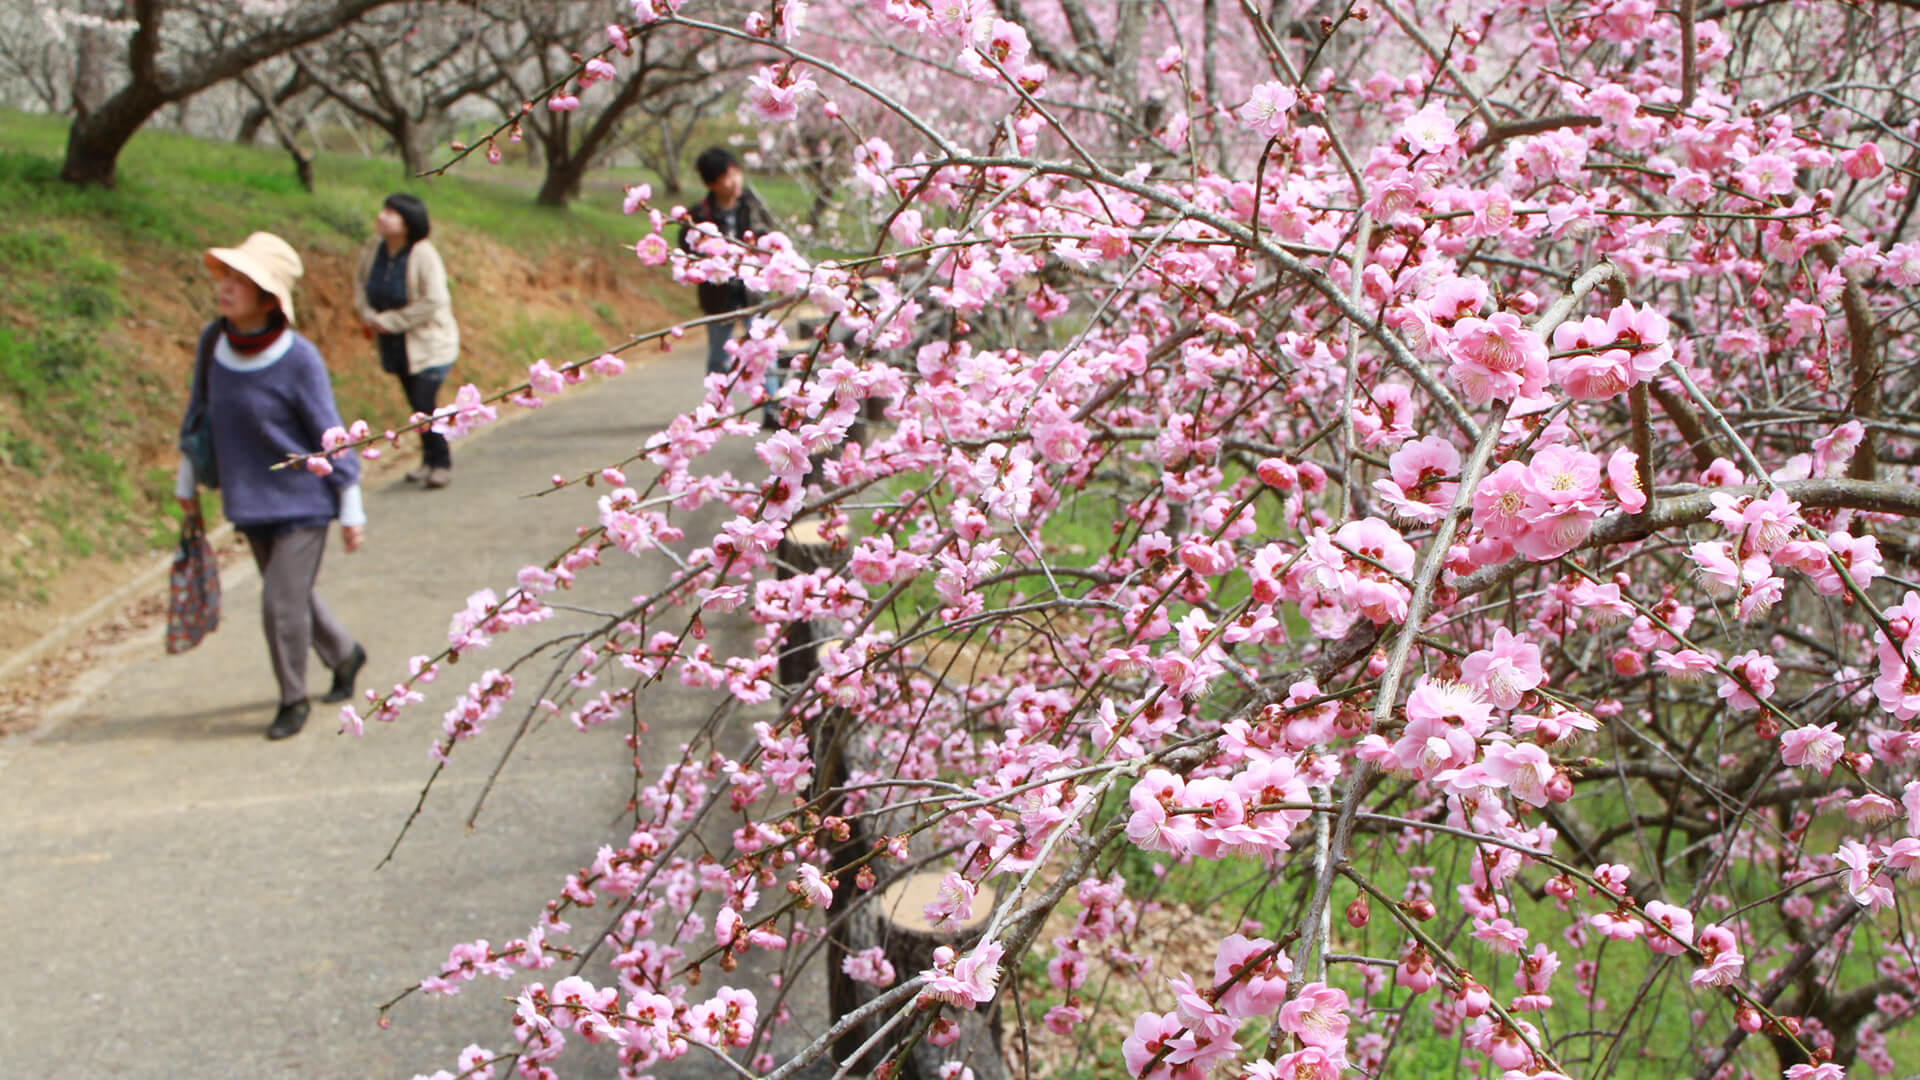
top-left (175, 233), bottom-right (367, 738)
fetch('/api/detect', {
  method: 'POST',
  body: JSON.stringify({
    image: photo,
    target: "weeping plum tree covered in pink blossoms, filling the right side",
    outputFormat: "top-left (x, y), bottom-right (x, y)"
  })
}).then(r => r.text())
top-left (309, 0), bottom-right (1920, 1080)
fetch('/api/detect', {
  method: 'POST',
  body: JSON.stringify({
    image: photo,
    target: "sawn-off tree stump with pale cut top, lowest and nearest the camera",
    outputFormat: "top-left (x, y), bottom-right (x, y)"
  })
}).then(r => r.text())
top-left (833, 872), bottom-right (1012, 1080)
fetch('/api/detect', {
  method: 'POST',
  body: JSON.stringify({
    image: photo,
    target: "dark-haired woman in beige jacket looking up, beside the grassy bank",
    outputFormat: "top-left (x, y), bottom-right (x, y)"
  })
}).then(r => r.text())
top-left (353, 194), bottom-right (461, 488)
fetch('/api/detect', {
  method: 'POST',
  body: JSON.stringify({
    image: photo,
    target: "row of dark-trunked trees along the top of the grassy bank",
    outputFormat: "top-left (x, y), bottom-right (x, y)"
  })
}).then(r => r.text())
top-left (0, 0), bottom-right (749, 206)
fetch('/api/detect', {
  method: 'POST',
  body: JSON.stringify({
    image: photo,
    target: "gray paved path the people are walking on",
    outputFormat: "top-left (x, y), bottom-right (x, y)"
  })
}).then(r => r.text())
top-left (0, 342), bottom-right (787, 1080)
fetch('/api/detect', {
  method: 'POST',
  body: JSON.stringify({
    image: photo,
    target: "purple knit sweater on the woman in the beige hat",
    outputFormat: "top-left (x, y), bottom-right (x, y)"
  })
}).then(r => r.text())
top-left (182, 323), bottom-right (361, 528)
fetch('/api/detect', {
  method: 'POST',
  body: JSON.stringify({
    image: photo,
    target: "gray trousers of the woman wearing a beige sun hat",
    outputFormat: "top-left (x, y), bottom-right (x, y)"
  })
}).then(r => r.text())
top-left (246, 525), bottom-right (353, 705)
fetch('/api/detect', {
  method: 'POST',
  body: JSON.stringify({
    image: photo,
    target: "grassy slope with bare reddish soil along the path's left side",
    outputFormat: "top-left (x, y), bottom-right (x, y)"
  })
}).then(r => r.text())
top-left (0, 111), bottom-right (691, 655)
